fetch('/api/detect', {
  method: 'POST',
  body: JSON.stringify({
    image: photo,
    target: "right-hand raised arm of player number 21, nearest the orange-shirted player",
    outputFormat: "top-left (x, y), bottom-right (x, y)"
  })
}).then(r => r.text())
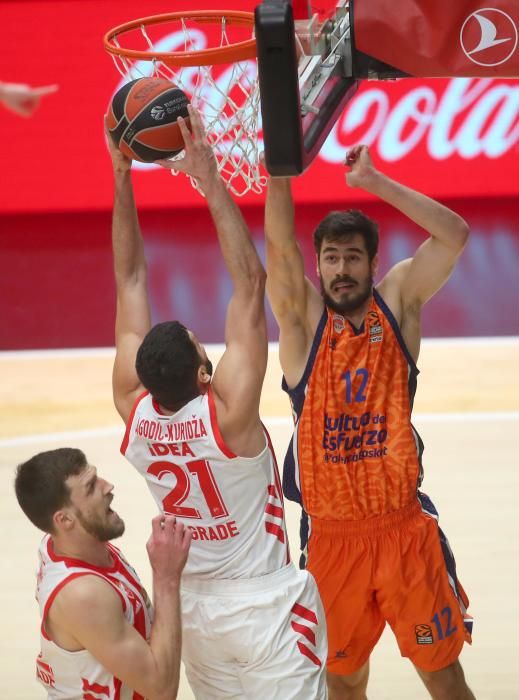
top-left (161, 107), bottom-right (267, 456)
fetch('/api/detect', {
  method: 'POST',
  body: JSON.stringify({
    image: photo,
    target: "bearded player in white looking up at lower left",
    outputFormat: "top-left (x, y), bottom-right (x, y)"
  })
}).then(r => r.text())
top-left (15, 448), bottom-right (191, 700)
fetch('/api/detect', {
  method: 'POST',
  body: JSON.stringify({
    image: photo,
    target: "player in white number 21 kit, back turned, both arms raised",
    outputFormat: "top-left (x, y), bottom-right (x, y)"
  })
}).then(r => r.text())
top-left (110, 108), bottom-right (326, 700)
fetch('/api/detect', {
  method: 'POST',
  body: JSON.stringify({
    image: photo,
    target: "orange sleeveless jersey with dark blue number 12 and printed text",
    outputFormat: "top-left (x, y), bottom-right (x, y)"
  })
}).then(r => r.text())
top-left (283, 290), bottom-right (423, 524)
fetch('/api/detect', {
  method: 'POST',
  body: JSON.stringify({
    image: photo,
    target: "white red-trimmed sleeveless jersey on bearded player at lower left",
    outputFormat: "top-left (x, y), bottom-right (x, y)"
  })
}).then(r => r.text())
top-left (36, 535), bottom-right (153, 700)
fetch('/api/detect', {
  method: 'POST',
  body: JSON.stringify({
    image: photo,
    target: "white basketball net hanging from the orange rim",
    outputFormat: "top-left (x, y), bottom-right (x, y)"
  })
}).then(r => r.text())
top-left (108, 18), bottom-right (267, 197)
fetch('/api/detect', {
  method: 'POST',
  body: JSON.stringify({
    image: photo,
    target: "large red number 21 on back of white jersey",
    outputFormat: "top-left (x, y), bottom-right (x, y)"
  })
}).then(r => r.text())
top-left (148, 459), bottom-right (229, 519)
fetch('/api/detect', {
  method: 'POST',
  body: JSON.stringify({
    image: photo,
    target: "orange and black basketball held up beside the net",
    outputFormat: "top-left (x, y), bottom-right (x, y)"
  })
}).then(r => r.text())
top-left (108, 78), bottom-right (189, 163)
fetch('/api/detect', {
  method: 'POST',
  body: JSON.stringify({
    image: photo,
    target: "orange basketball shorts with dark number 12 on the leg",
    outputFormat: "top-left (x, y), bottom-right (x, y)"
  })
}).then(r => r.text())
top-left (307, 494), bottom-right (472, 675)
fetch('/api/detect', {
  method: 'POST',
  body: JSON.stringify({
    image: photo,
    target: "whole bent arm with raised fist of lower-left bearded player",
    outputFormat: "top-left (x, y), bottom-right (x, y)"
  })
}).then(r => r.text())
top-left (49, 515), bottom-right (191, 700)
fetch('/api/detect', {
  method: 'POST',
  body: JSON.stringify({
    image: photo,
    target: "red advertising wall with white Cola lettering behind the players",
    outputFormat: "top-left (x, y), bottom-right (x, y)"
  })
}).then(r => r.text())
top-left (0, 0), bottom-right (519, 350)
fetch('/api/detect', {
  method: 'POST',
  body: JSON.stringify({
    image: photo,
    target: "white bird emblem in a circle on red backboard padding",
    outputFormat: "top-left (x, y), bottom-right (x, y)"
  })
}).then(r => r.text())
top-left (460, 7), bottom-right (519, 67)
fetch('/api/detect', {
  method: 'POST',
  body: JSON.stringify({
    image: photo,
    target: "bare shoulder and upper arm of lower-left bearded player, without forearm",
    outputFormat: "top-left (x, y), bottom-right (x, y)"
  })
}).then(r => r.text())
top-left (49, 575), bottom-right (180, 700)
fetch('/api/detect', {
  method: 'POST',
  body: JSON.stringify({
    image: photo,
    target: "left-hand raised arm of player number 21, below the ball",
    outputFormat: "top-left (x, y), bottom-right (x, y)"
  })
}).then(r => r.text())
top-left (106, 119), bottom-right (151, 423)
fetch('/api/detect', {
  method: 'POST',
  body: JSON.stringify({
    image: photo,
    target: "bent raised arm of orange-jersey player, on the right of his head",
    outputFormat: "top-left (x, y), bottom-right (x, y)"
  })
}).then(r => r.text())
top-left (346, 146), bottom-right (469, 311)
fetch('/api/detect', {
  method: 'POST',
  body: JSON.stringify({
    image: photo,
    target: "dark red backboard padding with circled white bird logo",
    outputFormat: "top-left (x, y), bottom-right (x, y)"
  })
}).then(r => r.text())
top-left (352, 0), bottom-right (519, 78)
